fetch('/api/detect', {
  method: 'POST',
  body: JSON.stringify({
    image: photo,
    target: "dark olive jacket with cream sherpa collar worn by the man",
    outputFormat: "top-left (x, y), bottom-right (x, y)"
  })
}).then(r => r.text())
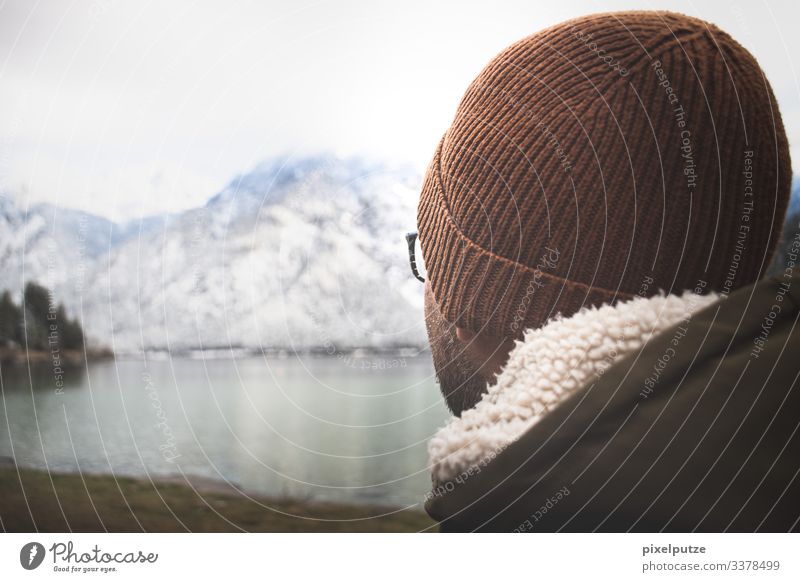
top-left (426, 268), bottom-right (800, 532)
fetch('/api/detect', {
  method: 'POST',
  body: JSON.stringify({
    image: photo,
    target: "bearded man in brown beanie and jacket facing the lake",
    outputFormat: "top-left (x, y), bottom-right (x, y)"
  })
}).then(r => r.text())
top-left (412, 12), bottom-right (800, 532)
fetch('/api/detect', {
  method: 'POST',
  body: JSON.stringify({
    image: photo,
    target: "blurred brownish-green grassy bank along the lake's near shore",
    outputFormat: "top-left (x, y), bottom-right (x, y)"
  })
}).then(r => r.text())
top-left (0, 467), bottom-right (434, 532)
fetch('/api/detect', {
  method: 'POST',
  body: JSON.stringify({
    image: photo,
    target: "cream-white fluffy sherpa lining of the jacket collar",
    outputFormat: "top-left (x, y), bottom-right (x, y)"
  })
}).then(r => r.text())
top-left (428, 291), bottom-right (719, 483)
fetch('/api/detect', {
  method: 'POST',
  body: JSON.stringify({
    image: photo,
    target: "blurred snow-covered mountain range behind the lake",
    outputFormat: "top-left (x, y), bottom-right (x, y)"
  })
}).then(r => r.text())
top-left (0, 156), bottom-right (425, 353)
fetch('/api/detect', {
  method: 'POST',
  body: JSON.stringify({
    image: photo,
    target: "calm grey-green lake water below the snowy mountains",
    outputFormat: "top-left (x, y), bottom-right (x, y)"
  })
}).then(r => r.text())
top-left (0, 354), bottom-right (448, 507)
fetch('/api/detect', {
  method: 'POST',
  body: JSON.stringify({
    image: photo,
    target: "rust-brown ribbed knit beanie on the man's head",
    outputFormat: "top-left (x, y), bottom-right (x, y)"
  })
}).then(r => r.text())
top-left (418, 11), bottom-right (791, 337)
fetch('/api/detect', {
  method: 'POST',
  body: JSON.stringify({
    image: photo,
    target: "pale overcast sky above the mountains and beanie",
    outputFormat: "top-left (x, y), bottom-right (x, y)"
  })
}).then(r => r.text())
top-left (0, 0), bottom-right (800, 219)
